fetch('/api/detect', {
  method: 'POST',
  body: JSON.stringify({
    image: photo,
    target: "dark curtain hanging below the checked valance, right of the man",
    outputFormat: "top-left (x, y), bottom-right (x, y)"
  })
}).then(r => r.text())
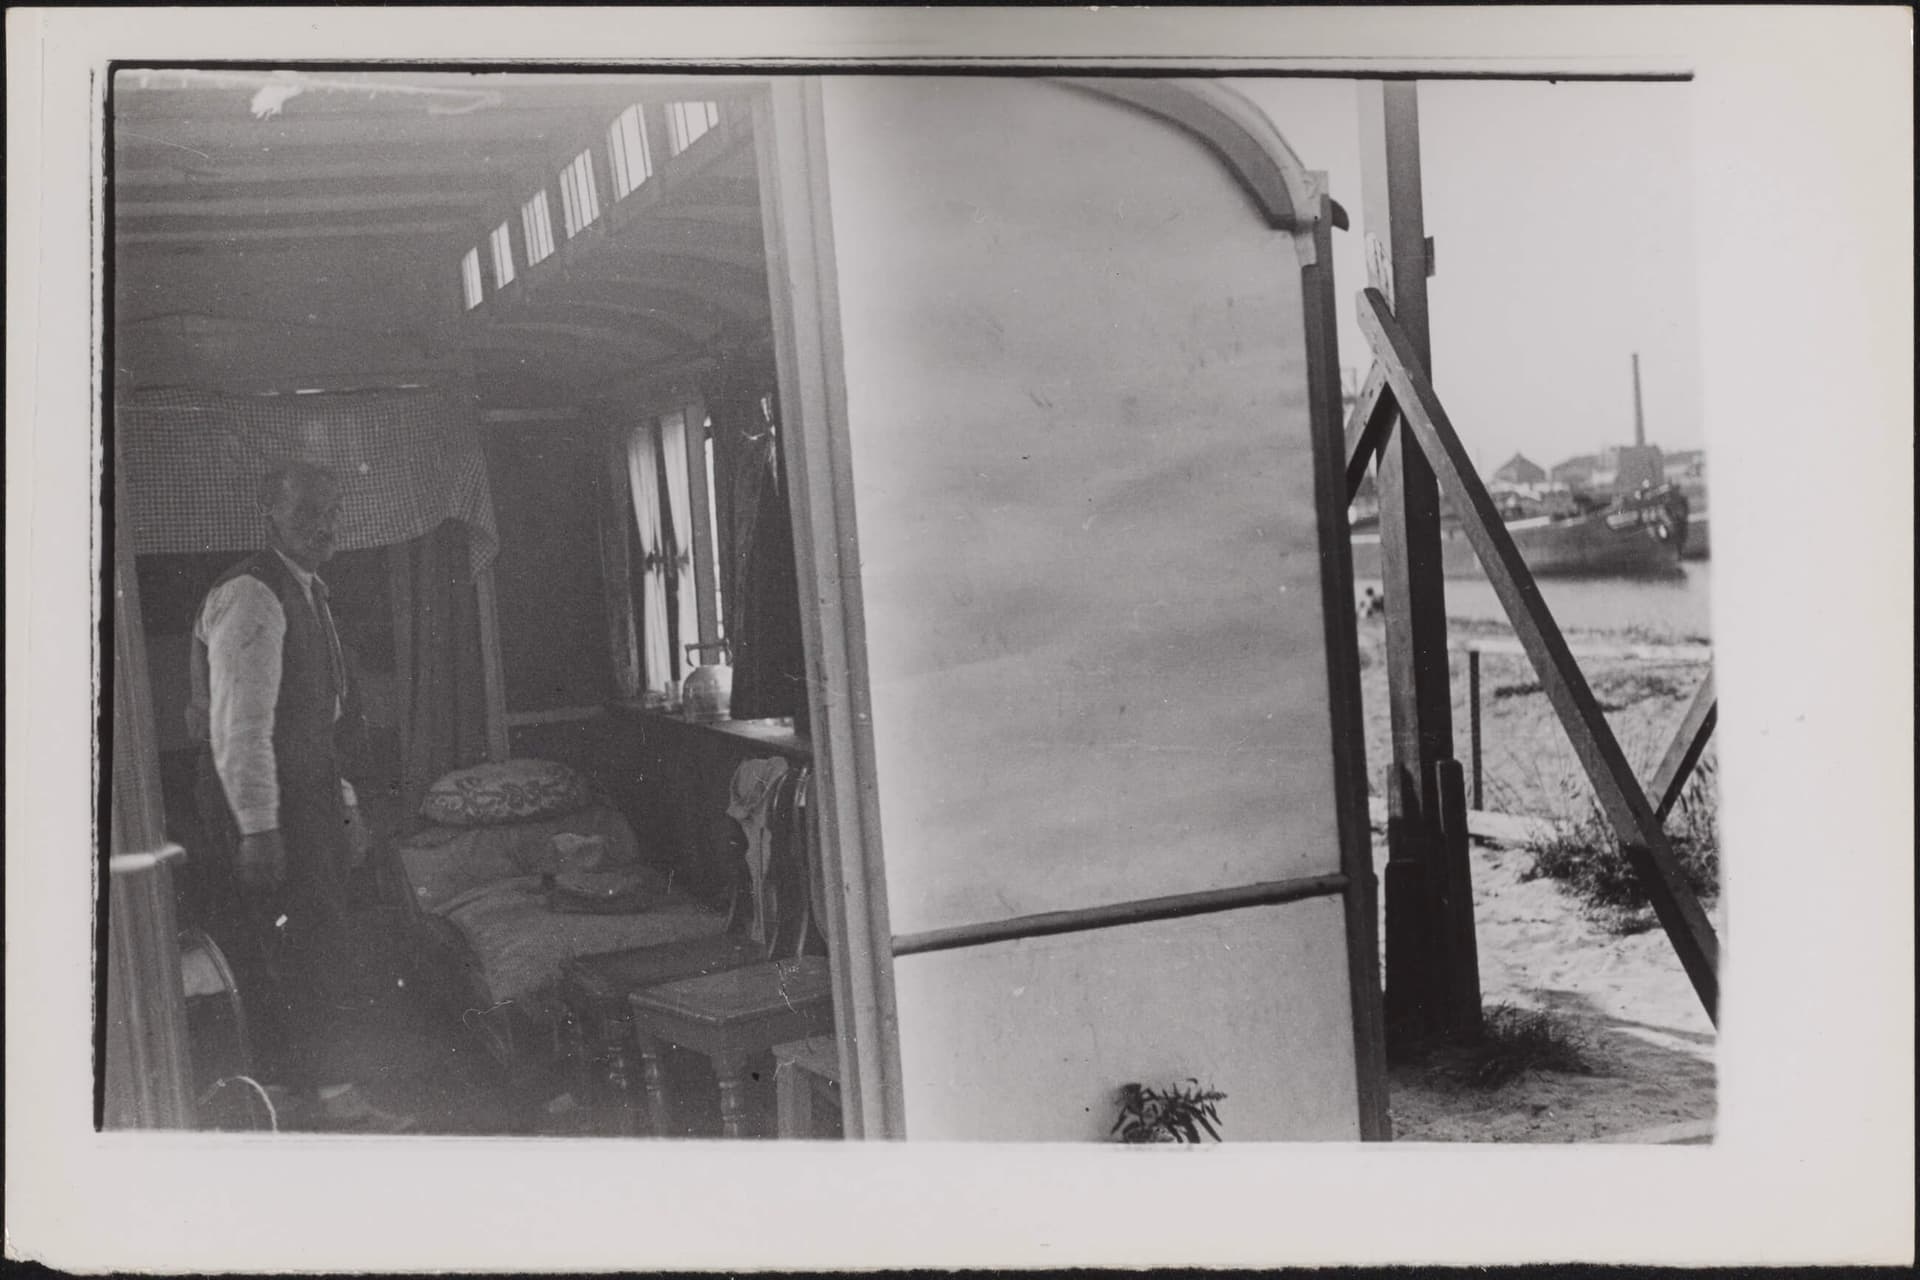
top-left (394, 520), bottom-right (488, 814)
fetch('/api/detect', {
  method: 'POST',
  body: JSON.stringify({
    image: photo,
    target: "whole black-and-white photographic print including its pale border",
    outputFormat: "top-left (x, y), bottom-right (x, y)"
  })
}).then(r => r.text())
top-left (8, 10), bottom-right (1912, 1270)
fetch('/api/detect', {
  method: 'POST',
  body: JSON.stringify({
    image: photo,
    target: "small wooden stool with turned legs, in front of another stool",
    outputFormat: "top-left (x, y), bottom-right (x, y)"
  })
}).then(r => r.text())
top-left (628, 956), bottom-right (833, 1138)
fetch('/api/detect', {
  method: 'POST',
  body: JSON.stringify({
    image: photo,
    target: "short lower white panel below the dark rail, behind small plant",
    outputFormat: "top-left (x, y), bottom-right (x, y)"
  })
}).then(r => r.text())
top-left (895, 898), bottom-right (1359, 1142)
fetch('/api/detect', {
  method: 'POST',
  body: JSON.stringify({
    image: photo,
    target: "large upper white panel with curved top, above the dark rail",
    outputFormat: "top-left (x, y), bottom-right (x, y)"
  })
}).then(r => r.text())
top-left (824, 79), bottom-right (1344, 940)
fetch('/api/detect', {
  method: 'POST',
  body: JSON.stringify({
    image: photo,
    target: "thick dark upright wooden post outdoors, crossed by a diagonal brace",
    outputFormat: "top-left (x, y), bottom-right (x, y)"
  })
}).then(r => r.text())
top-left (1350, 81), bottom-right (1480, 1040)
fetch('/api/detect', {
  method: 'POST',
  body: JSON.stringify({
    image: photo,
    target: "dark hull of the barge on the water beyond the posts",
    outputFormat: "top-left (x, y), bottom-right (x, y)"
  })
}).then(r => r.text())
top-left (1354, 505), bottom-right (1688, 578)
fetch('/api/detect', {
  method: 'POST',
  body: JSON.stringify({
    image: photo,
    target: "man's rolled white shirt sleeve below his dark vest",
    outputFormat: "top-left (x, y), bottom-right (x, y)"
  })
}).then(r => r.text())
top-left (200, 574), bottom-right (286, 835)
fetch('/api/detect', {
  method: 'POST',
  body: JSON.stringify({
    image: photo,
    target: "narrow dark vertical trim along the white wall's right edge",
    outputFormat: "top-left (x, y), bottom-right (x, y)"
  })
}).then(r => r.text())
top-left (1296, 175), bottom-right (1394, 1142)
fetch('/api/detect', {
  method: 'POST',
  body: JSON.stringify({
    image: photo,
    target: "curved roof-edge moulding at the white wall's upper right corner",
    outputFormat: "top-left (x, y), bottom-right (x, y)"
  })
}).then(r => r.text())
top-left (1056, 77), bottom-right (1344, 232)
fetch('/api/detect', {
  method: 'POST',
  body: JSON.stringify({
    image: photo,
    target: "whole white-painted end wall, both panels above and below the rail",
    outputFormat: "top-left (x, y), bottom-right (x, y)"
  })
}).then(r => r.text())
top-left (802, 77), bottom-right (1357, 1138)
